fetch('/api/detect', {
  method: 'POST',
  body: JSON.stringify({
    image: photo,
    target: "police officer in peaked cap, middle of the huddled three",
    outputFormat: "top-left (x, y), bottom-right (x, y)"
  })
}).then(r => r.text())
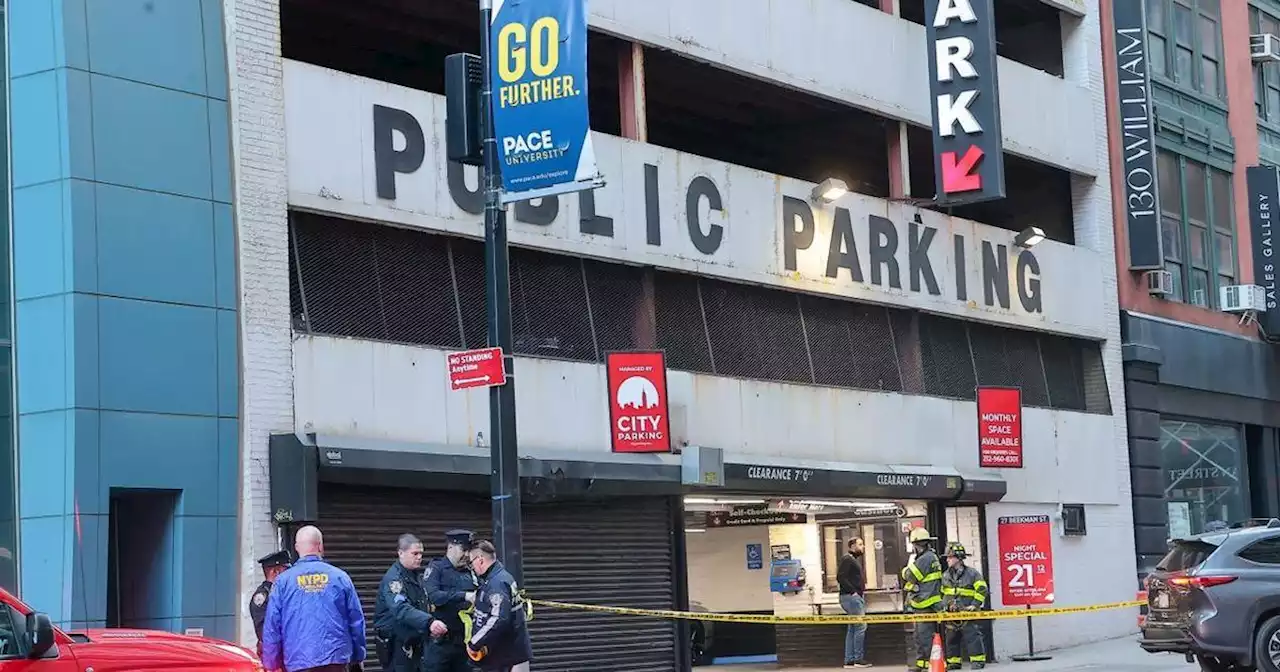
top-left (422, 530), bottom-right (479, 672)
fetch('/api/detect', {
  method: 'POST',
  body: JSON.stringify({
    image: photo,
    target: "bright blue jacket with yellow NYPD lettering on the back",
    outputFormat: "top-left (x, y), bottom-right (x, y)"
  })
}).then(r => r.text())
top-left (262, 556), bottom-right (365, 671)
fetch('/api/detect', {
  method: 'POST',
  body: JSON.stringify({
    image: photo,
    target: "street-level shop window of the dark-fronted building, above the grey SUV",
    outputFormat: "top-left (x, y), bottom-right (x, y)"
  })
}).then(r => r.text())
top-left (1160, 420), bottom-right (1245, 539)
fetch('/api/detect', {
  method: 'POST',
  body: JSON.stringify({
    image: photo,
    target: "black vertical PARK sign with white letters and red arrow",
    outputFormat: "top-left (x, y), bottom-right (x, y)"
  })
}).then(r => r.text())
top-left (924, 0), bottom-right (1005, 205)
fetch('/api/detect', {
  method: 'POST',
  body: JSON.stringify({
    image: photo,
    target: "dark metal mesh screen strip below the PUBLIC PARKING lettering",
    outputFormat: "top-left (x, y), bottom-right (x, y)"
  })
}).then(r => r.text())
top-left (289, 212), bottom-right (1111, 413)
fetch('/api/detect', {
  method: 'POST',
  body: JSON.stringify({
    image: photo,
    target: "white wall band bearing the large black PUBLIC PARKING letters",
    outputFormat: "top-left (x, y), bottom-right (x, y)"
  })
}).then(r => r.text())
top-left (284, 60), bottom-right (1116, 338)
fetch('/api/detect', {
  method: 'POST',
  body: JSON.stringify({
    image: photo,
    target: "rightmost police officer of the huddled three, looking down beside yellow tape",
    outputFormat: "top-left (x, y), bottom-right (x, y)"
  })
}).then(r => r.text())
top-left (467, 541), bottom-right (534, 672)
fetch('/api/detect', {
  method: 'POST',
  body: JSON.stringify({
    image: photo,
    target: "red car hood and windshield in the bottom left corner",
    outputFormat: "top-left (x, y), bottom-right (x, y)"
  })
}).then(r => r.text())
top-left (0, 589), bottom-right (262, 672)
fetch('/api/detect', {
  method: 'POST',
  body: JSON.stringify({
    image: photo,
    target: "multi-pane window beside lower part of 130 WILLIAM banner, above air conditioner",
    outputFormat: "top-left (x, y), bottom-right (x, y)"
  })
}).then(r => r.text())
top-left (1156, 151), bottom-right (1235, 307)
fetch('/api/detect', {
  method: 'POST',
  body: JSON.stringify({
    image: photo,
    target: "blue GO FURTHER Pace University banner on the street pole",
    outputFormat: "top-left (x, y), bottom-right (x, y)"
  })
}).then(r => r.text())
top-left (488, 0), bottom-right (604, 204)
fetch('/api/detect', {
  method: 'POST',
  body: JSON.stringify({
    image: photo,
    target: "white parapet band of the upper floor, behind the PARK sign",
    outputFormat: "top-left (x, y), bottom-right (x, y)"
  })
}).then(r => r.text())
top-left (589, 0), bottom-right (1106, 175)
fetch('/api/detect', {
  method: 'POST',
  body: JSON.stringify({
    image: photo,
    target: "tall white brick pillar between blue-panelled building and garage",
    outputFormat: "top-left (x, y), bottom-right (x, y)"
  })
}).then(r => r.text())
top-left (223, 0), bottom-right (293, 645)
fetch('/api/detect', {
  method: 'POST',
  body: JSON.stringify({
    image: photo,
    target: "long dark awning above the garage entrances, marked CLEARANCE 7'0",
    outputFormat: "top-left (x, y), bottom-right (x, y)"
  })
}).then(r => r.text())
top-left (270, 434), bottom-right (1006, 517)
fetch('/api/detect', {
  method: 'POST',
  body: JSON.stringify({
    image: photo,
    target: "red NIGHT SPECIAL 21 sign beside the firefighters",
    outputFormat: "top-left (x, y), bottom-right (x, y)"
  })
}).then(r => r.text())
top-left (996, 515), bottom-right (1053, 607)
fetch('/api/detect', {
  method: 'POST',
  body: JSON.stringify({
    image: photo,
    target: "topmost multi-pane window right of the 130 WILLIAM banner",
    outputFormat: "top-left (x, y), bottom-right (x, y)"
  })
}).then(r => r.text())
top-left (1146, 0), bottom-right (1225, 99)
